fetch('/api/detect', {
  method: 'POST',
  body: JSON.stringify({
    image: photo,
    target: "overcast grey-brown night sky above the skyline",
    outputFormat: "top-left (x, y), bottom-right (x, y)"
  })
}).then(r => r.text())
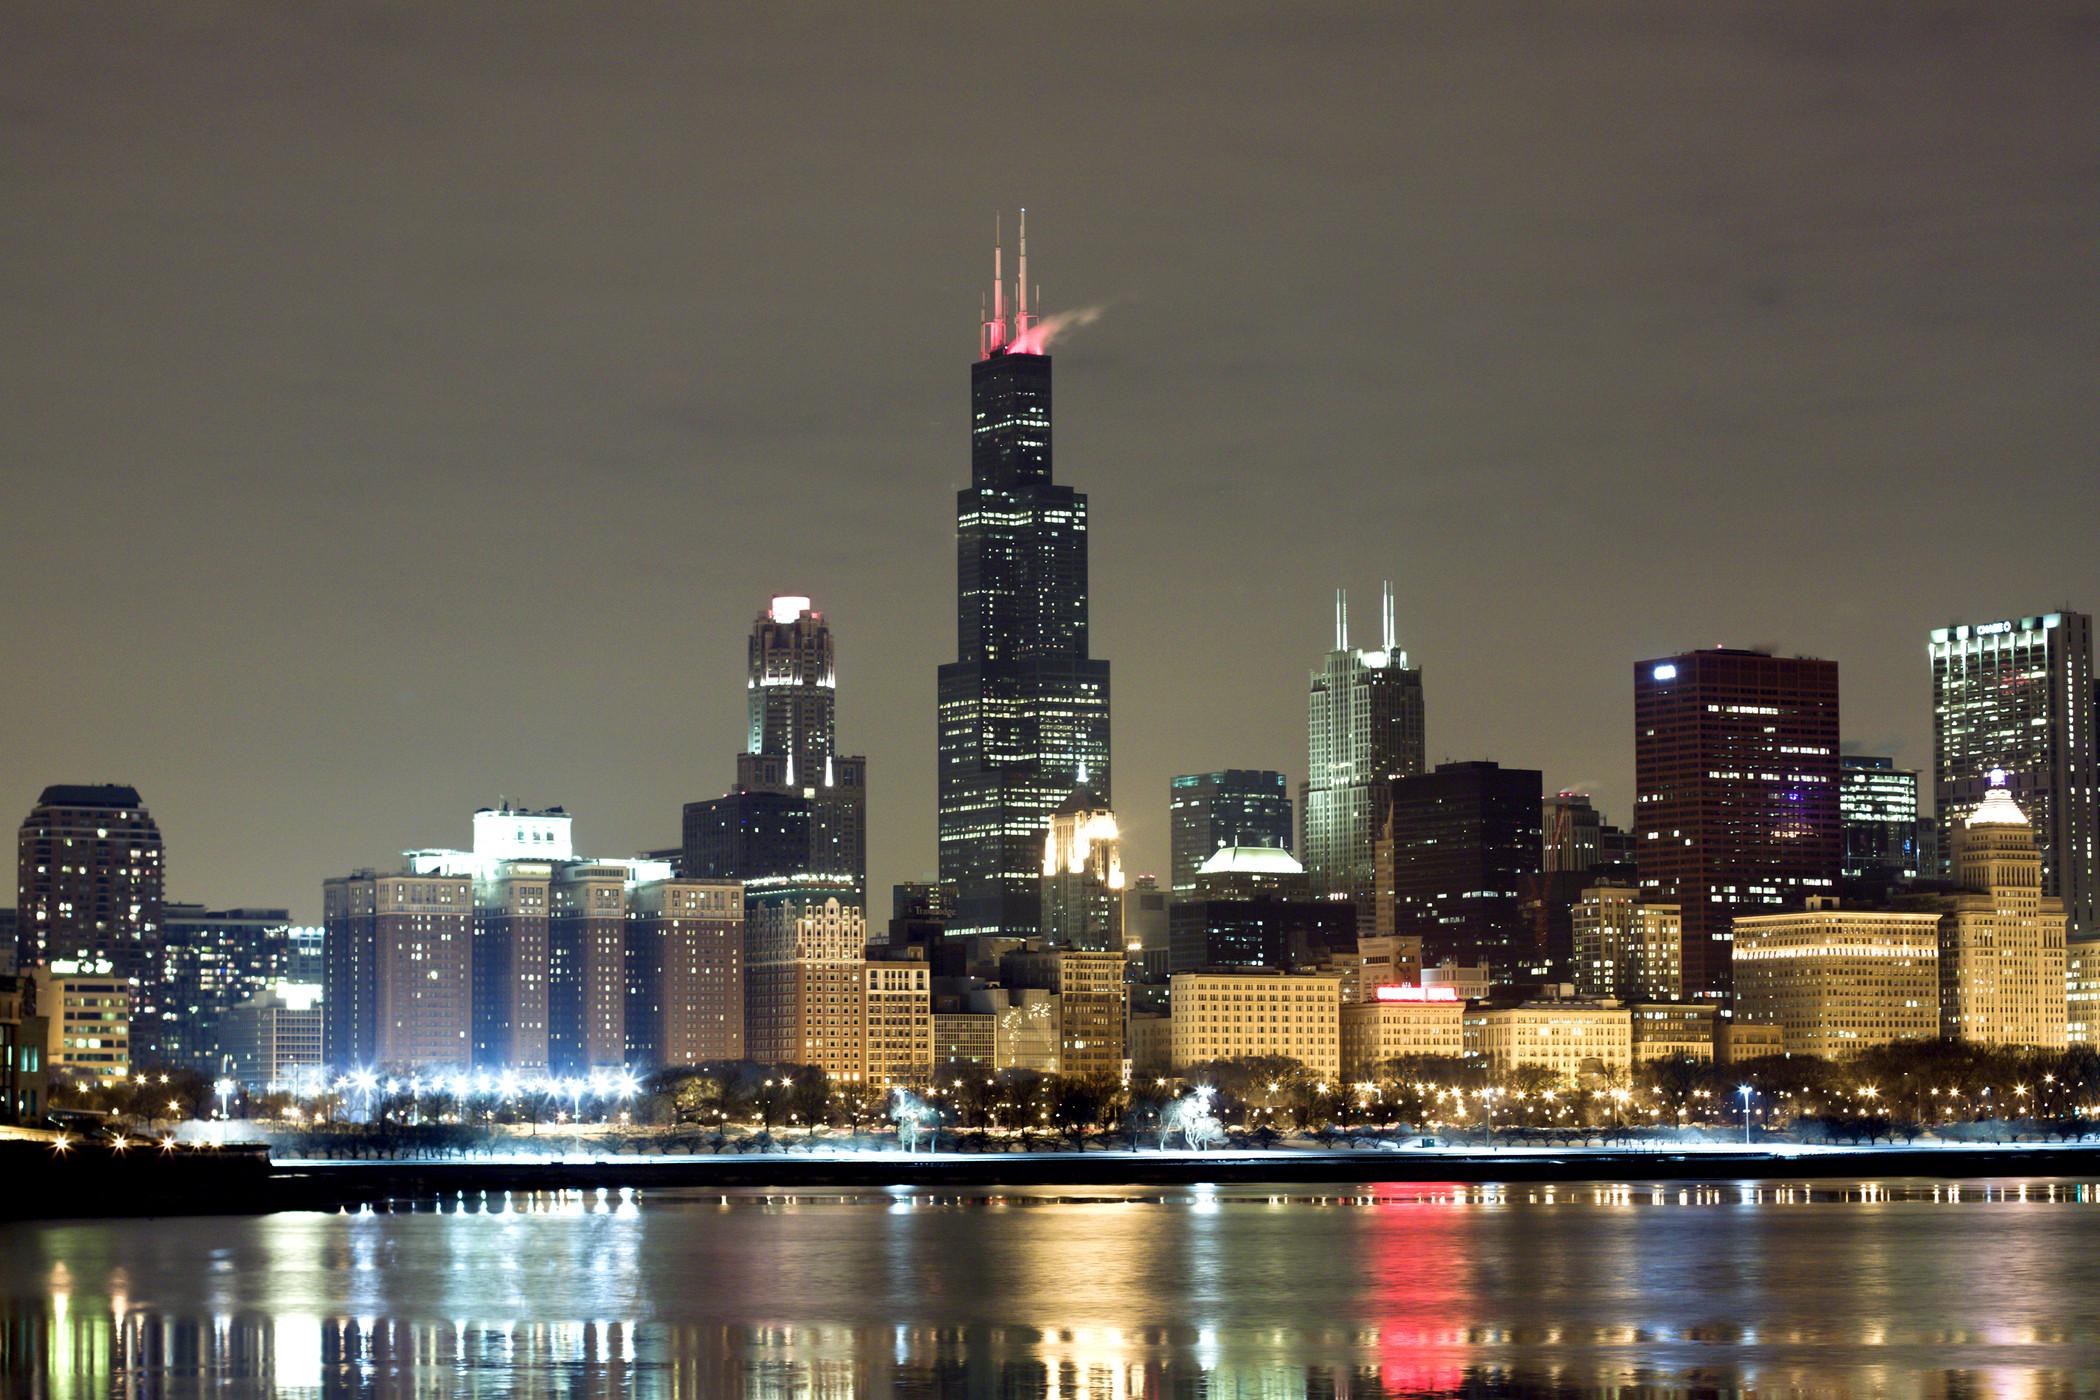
top-left (0, 2), bottom-right (2100, 919)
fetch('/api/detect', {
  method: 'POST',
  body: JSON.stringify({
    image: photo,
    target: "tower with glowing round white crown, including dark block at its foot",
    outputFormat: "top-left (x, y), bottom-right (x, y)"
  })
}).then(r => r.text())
top-left (683, 596), bottom-right (867, 909)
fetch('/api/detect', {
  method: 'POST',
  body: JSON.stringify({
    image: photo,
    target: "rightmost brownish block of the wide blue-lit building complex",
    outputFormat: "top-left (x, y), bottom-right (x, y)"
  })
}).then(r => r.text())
top-left (626, 879), bottom-right (743, 1068)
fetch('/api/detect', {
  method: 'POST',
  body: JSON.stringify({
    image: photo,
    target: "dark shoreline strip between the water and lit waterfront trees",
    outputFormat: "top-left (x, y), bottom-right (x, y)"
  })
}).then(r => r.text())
top-left (16, 1144), bottom-right (2100, 1222)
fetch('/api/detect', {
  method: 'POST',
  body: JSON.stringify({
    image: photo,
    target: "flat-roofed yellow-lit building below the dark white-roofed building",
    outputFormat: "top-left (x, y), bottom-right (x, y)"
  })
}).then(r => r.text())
top-left (1170, 970), bottom-right (1342, 1075)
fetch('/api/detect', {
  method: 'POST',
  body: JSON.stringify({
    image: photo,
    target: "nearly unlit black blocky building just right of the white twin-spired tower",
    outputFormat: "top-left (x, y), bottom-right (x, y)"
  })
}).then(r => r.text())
top-left (1378, 762), bottom-right (1544, 982)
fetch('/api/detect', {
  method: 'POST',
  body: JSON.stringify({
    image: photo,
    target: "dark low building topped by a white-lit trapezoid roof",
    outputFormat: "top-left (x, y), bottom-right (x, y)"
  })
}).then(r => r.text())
top-left (1168, 846), bottom-right (1357, 972)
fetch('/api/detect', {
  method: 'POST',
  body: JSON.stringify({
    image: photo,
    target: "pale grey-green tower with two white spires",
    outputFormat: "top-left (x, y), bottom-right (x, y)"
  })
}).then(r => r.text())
top-left (1298, 584), bottom-right (1427, 915)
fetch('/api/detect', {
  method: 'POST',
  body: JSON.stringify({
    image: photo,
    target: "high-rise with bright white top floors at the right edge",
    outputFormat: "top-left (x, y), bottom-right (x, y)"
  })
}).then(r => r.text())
top-left (1928, 613), bottom-right (2100, 934)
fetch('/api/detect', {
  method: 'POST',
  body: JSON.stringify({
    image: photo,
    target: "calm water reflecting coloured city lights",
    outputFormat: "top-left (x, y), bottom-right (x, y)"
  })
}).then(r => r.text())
top-left (0, 1182), bottom-right (2100, 1398)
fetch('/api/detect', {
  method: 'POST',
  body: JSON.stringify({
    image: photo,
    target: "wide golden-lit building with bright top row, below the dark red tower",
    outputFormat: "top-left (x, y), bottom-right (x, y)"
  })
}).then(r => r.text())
top-left (1735, 896), bottom-right (1940, 1060)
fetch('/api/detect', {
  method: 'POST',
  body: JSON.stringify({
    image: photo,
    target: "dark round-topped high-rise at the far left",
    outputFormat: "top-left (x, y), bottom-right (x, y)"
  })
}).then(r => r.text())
top-left (15, 783), bottom-right (166, 982)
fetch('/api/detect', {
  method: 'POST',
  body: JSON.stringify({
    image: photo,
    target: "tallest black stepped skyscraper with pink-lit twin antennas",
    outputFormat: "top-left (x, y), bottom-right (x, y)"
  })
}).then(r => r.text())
top-left (939, 214), bottom-right (1111, 934)
